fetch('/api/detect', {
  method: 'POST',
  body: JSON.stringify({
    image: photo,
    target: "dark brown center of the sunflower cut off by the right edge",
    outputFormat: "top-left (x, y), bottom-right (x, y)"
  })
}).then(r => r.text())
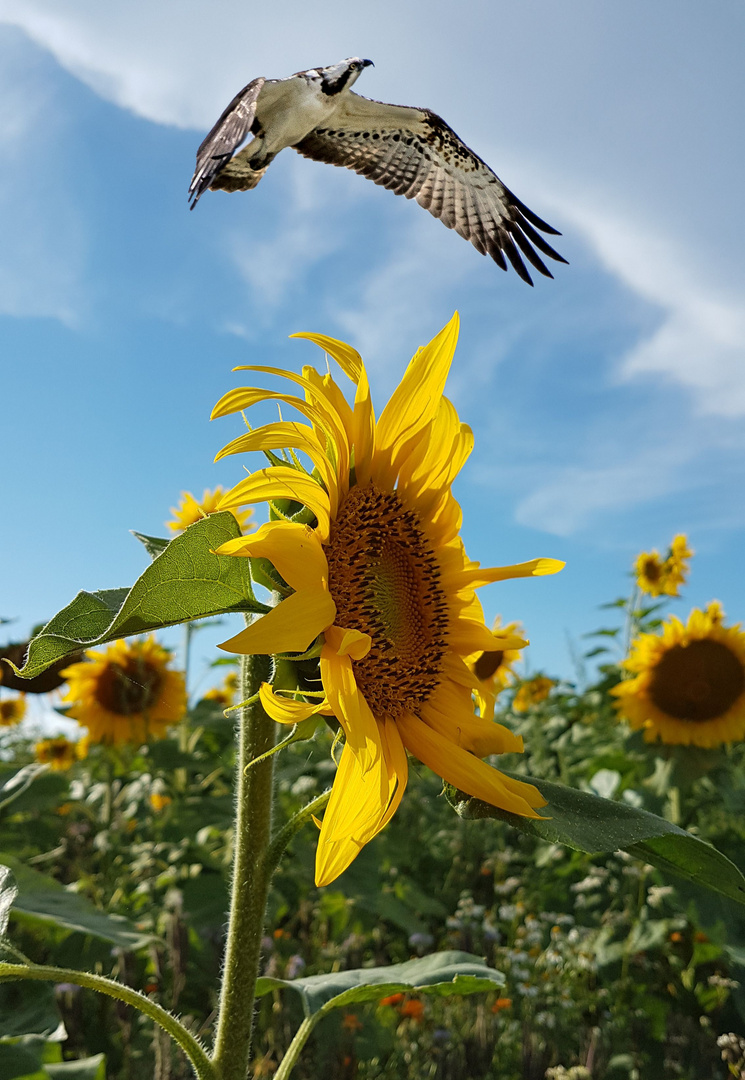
top-left (649, 638), bottom-right (745, 723)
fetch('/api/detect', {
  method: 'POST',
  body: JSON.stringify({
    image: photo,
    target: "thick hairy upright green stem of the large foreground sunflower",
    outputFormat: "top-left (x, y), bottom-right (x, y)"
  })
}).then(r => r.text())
top-left (212, 657), bottom-right (274, 1080)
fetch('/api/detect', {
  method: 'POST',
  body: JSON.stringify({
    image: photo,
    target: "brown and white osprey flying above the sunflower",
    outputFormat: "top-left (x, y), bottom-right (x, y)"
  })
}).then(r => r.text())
top-left (189, 56), bottom-right (567, 285)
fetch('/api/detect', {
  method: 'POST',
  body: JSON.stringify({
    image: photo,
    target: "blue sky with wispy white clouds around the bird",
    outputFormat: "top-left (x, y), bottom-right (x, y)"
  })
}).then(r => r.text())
top-left (0, 0), bottom-right (745, 708)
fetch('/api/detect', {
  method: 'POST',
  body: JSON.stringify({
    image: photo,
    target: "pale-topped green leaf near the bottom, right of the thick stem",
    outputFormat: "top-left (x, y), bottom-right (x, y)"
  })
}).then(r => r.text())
top-left (256, 950), bottom-right (505, 1016)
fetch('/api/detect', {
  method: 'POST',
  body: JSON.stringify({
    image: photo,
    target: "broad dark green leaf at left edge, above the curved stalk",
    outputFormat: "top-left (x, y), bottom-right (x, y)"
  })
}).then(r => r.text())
top-left (0, 852), bottom-right (151, 949)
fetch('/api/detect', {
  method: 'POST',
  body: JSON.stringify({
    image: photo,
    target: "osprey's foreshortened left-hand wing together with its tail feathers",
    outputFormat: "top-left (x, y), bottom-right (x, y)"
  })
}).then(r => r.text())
top-left (189, 76), bottom-right (267, 210)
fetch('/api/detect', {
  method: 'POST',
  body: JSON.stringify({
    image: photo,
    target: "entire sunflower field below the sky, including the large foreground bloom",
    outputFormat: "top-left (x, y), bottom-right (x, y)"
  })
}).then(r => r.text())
top-left (0, 319), bottom-right (745, 1080)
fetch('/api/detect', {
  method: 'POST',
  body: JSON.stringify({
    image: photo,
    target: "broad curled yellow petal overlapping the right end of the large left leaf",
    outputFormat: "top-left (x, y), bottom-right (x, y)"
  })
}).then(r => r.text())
top-left (215, 522), bottom-right (328, 596)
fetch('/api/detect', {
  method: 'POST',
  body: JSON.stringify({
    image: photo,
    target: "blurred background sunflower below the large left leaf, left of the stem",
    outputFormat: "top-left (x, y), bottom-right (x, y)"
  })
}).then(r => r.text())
top-left (62, 636), bottom-right (187, 745)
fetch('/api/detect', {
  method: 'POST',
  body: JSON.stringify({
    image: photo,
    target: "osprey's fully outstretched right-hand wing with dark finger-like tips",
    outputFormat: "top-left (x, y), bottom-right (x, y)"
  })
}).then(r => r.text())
top-left (295, 92), bottom-right (566, 285)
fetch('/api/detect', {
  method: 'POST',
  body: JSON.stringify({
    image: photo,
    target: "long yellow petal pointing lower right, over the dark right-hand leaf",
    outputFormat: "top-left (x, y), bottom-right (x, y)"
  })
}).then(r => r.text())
top-left (396, 714), bottom-right (546, 818)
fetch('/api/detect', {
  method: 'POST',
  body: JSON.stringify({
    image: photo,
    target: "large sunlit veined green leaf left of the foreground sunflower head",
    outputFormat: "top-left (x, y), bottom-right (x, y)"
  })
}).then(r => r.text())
top-left (13, 513), bottom-right (266, 678)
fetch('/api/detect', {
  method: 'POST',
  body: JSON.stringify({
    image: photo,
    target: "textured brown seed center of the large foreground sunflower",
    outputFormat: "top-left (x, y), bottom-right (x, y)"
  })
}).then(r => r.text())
top-left (326, 484), bottom-right (448, 718)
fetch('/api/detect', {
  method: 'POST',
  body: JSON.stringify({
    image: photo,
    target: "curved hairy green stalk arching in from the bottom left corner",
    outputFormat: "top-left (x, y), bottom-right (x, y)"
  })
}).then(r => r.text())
top-left (0, 963), bottom-right (217, 1080)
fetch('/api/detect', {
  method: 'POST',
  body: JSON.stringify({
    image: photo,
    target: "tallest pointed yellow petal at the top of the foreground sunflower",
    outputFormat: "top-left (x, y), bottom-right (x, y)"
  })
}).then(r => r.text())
top-left (374, 312), bottom-right (459, 486)
